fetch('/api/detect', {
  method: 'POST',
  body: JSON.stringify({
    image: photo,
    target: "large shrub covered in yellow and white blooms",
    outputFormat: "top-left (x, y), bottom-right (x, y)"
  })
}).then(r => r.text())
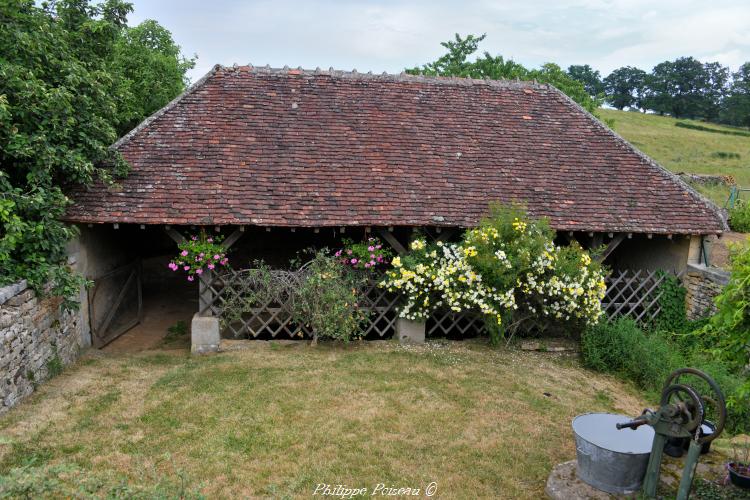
top-left (381, 204), bottom-right (606, 338)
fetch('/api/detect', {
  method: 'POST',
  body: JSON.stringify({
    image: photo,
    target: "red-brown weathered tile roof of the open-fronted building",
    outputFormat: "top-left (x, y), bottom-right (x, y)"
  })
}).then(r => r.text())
top-left (67, 66), bottom-right (725, 233)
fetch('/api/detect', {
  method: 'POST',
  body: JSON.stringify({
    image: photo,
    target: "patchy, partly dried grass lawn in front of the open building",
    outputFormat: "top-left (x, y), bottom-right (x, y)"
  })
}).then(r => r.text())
top-left (0, 341), bottom-right (644, 498)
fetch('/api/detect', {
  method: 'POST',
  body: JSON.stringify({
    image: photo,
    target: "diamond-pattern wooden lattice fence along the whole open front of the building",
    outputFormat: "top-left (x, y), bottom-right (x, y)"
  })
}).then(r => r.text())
top-left (200, 268), bottom-right (684, 338)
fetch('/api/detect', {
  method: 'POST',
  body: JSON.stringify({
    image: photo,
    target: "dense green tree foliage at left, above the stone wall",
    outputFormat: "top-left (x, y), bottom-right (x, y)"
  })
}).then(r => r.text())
top-left (0, 0), bottom-right (194, 298)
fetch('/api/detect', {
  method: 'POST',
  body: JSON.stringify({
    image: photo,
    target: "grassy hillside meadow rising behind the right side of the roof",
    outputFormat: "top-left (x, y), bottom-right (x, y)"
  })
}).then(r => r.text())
top-left (597, 109), bottom-right (750, 206)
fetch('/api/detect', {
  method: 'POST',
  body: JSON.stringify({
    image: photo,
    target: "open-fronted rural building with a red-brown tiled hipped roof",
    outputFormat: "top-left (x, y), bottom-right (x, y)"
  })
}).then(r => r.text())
top-left (61, 66), bottom-right (727, 345)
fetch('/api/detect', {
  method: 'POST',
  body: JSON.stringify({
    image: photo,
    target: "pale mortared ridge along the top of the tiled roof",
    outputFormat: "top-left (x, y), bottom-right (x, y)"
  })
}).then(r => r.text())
top-left (217, 63), bottom-right (552, 90)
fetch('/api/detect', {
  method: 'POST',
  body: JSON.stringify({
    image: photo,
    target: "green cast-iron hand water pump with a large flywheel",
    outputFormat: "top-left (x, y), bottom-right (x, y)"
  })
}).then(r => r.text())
top-left (617, 368), bottom-right (727, 500)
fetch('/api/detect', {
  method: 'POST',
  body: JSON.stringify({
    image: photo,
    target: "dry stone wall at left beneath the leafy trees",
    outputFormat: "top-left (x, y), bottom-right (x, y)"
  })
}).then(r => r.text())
top-left (0, 281), bottom-right (82, 414)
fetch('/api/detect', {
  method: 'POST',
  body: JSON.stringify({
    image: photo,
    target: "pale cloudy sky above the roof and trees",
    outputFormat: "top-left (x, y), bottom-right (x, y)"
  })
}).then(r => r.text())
top-left (130, 0), bottom-right (750, 81)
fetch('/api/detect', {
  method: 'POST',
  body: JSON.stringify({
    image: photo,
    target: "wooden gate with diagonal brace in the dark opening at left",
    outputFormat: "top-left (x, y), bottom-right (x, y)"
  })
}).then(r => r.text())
top-left (88, 261), bottom-right (143, 348)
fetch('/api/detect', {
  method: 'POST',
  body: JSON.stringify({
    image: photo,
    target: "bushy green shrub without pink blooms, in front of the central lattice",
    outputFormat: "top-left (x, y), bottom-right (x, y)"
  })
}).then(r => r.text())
top-left (292, 250), bottom-right (367, 344)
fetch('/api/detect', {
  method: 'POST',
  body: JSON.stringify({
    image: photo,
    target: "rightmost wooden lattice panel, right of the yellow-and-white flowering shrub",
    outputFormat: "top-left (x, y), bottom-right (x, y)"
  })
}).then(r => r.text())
top-left (602, 269), bottom-right (680, 323)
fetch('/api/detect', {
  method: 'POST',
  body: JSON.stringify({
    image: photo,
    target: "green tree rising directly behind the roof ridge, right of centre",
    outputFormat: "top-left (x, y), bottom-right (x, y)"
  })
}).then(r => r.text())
top-left (406, 33), bottom-right (597, 112)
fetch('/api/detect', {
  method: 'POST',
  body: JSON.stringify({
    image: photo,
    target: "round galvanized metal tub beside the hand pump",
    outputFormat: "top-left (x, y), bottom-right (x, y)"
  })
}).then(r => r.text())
top-left (573, 413), bottom-right (654, 495)
